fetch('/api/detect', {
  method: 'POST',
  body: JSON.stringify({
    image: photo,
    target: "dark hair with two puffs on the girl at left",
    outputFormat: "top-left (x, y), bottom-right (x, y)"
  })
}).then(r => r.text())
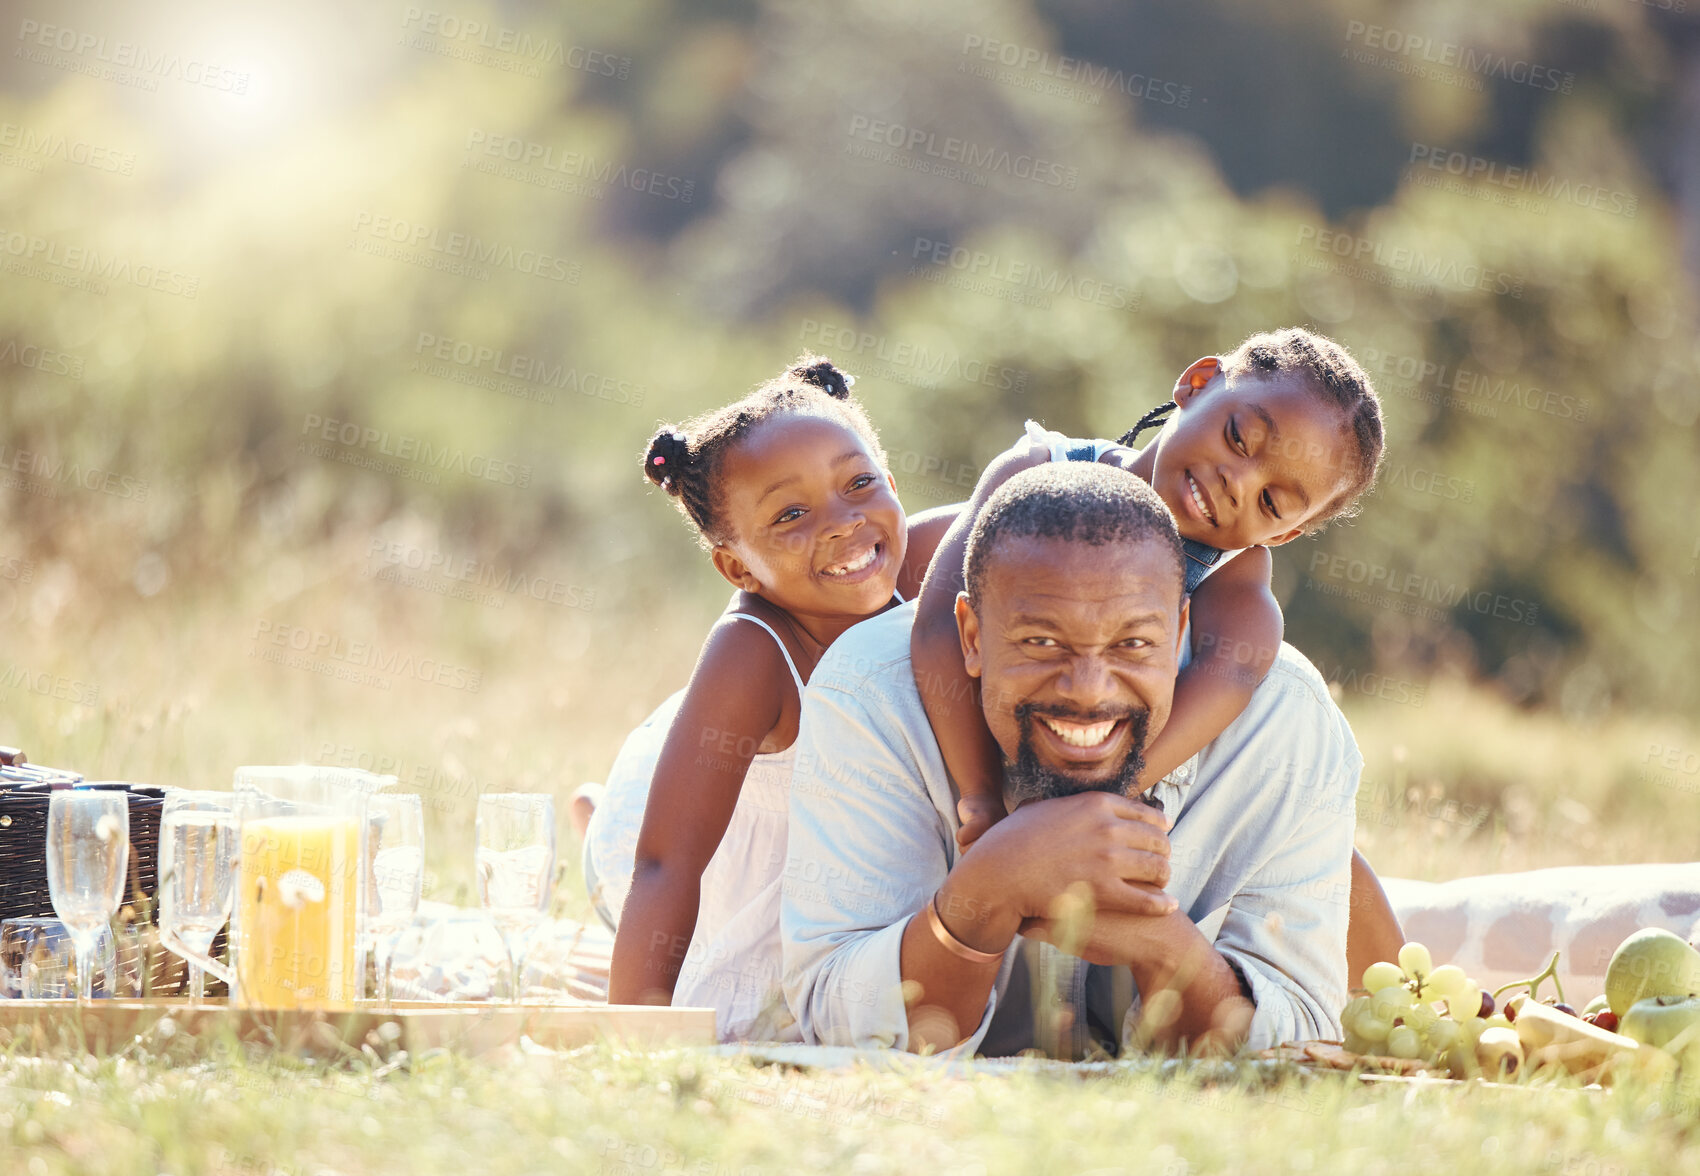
top-left (643, 355), bottom-right (886, 546)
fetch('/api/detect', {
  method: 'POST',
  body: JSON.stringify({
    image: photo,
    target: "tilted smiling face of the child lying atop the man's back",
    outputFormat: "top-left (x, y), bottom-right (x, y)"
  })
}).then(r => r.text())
top-left (1151, 364), bottom-right (1353, 549)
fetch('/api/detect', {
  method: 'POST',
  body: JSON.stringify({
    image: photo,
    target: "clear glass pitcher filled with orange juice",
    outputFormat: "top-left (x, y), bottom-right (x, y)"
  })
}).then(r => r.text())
top-left (172, 766), bottom-right (394, 1008)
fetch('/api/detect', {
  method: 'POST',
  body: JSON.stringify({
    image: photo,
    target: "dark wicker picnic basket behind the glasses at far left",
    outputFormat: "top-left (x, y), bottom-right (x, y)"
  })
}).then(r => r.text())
top-left (0, 748), bottom-right (224, 996)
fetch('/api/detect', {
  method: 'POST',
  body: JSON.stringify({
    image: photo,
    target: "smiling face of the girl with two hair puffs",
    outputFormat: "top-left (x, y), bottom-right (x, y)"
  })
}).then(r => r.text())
top-left (714, 413), bottom-right (908, 617)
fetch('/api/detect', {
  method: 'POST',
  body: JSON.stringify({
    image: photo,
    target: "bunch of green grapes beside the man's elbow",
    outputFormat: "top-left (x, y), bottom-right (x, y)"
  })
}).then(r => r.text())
top-left (1340, 943), bottom-right (1493, 1071)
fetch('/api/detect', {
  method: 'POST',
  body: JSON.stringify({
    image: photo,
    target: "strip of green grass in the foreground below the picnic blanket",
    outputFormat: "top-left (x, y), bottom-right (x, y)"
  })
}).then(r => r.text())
top-left (0, 1047), bottom-right (1700, 1176)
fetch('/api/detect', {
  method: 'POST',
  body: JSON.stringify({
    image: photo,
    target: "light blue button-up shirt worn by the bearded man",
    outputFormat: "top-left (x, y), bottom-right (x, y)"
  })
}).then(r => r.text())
top-left (780, 603), bottom-right (1363, 1050)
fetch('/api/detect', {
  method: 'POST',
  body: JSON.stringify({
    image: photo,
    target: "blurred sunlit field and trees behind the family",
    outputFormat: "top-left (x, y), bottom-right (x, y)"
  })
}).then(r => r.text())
top-left (0, 0), bottom-right (1700, 907)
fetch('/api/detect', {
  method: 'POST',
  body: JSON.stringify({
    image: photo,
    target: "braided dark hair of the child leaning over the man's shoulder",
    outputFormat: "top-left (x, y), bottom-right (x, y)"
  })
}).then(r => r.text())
top-left (1120, 326), bottom-right (1386, 527)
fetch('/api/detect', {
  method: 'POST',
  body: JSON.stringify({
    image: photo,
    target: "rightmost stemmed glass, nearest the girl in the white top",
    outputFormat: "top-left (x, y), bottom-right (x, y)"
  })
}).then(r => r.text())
top-left (476, 792), bottom-right (554, 999)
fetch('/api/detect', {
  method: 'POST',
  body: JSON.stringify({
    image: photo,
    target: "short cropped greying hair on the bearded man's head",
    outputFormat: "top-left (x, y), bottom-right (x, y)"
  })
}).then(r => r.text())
top-left (962, 462), bottom-right (1187, 613)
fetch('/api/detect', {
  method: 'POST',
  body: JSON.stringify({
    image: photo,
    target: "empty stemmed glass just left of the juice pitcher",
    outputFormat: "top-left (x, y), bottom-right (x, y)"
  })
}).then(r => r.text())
top-left (160, 789), bottom-right (236, 1006)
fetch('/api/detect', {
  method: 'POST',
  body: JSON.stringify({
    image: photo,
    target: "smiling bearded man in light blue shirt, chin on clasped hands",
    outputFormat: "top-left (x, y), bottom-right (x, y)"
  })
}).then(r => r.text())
top-left (782, 464), bottom-right (1362, 1057)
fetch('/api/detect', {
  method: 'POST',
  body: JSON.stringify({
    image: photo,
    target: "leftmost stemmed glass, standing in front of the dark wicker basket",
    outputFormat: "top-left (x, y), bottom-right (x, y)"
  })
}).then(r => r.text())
top-left (48, 789), bottom-right (129, 1004)
